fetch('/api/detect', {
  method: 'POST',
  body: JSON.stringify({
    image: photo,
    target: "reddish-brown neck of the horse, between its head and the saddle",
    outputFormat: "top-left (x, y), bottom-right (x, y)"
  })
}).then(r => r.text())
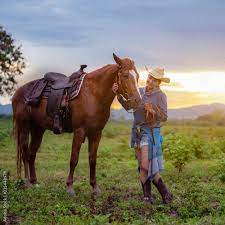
top-left (87, 64), bottom-right (118, 106)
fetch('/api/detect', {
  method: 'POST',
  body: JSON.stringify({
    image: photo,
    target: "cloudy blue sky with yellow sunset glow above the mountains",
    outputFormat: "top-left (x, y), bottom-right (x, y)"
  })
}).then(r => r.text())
top-left (0, 0), bottom-right (225, 108)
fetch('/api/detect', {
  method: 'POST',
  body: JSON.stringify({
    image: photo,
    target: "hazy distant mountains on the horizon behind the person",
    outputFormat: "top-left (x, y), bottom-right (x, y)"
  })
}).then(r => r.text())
top-left (111, 103), bottom-right (225, 120)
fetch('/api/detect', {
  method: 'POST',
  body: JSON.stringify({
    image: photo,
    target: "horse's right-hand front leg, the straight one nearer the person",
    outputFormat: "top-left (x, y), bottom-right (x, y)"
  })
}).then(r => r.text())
top-left (88, 131), bottom-right (102, 194)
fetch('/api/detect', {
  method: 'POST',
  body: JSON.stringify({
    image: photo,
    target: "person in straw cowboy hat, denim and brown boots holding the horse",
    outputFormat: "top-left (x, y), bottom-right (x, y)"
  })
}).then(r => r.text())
top-left (112, 68), bottom-right (173, 204)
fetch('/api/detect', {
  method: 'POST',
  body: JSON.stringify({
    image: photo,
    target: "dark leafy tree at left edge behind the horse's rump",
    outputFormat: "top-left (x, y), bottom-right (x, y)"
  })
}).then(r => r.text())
top-left (0, 26), bottom-right (26, 95)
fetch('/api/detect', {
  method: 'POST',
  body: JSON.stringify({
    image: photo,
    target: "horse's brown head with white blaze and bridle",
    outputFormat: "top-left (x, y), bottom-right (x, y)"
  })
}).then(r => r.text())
top-left (113, 53), bottom-right (141, 110)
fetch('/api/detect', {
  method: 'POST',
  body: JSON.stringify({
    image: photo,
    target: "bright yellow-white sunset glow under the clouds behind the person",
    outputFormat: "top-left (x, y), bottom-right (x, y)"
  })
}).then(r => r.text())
top-left (133, 71), bottom-right (225, 108)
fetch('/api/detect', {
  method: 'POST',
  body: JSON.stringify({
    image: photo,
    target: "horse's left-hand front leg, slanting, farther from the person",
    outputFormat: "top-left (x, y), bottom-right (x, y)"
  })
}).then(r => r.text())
top-left (66, 128), bottom-right (85, 195)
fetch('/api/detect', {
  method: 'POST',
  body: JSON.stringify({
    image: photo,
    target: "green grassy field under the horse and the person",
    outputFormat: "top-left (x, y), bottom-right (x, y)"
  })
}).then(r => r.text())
top-left (0, 119), bottom-right (225, 225)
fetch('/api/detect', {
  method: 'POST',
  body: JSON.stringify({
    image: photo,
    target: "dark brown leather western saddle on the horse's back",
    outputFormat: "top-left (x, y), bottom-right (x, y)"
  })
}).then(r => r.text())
top-left (24, 65), bottom-right (87, 134)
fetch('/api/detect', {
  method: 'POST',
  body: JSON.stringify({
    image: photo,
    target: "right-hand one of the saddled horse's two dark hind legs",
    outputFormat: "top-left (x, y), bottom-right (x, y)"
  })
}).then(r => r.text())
top-left (29, 127), bottom-right (45, 184)
